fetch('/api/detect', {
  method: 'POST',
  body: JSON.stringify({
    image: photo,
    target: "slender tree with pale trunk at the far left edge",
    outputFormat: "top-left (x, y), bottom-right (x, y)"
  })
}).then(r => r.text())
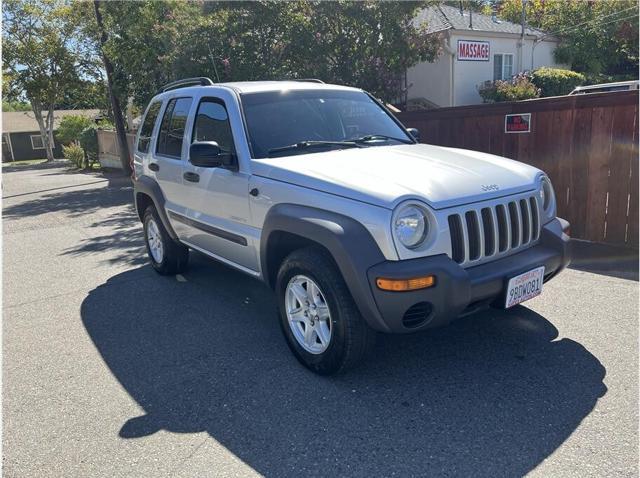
top-left (2, 0), bottom-right (89, 161)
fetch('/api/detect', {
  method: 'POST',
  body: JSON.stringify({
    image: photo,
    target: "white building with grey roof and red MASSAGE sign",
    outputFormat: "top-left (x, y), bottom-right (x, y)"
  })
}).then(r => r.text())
top-left (406, 5), bottom-right (564, 108)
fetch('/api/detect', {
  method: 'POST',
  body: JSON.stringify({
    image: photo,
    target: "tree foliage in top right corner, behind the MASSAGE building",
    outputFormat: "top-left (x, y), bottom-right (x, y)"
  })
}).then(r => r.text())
top-left (497, 0), bottom-right (638, 79)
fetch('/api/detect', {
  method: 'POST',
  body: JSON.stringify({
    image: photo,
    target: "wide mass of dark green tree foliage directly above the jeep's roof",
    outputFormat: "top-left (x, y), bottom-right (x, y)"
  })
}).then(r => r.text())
top-left (74, 0), bottom-right (442, 106)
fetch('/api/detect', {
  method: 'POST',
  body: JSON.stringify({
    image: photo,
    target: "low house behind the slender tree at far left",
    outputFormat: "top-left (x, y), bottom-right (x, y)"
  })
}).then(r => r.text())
top-left (2, 110), bottom-right (101, 163)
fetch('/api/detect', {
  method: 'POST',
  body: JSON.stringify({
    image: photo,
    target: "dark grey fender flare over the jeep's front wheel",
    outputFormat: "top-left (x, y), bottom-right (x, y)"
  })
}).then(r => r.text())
top-left (260, 204), bottom-right (389, 331)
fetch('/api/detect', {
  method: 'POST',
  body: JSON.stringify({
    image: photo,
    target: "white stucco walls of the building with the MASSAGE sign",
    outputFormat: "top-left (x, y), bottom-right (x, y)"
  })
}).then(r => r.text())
top-left (407, 32), bottom-right (565, 106)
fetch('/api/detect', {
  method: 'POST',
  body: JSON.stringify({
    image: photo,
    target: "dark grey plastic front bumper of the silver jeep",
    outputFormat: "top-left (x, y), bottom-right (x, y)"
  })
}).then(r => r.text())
top-left (366, 218), bottom-right (571, 333)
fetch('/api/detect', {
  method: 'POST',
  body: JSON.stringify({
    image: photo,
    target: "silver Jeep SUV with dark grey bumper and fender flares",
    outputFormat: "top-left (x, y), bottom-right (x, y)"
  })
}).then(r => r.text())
top-left (134, 78), bottom-right (570, 374)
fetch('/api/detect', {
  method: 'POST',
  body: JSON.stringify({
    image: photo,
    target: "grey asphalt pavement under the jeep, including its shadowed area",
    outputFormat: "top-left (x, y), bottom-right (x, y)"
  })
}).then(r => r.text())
top-left (2, 167), bottom-right (638, 477)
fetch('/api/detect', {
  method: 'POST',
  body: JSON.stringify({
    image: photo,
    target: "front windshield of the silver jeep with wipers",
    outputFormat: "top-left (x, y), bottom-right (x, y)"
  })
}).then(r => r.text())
top-left (242, 89), bottom-right (414, 158)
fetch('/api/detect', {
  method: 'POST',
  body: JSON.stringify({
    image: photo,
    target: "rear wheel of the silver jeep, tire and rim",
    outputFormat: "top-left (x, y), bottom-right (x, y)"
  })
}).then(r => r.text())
top-left (143, 206), bottom-right (189, 275)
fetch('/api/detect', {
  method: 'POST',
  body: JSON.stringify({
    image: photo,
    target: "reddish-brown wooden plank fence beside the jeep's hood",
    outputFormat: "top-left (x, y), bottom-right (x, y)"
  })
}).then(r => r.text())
top-left (397, 90), bottom-right (638, 247)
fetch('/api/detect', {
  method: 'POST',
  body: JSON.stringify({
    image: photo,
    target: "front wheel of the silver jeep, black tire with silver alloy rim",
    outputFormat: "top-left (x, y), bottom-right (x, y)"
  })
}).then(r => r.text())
top-left (276, 248), bottom-right (376, 375)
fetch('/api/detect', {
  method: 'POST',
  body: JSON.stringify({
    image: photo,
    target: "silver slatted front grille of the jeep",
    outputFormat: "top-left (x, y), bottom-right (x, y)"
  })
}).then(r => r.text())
top-left (448, 195), bottom-right (540, 266)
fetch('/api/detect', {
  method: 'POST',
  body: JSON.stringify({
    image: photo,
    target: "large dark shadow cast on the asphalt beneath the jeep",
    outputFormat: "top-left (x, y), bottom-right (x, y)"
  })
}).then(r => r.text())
top-left (81, 254), bottom-right (607, 476)
